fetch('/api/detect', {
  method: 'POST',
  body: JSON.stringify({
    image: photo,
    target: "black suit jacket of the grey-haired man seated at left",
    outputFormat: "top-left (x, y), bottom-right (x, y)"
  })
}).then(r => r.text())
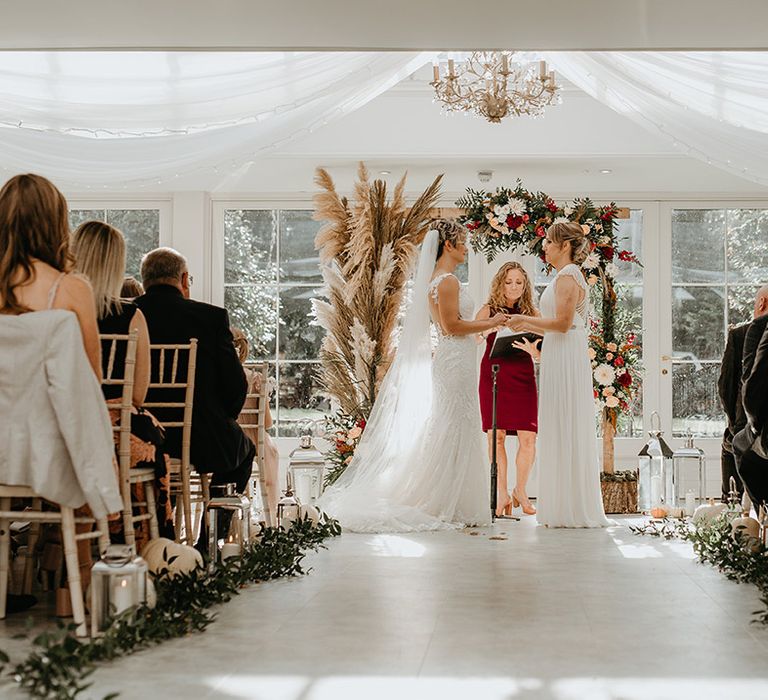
top-left (135, 284), bottom-right (251, 472)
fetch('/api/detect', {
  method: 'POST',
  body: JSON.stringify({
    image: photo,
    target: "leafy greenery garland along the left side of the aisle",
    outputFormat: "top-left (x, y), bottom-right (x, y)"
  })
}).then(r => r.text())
top-left (0, 515), bottom-right (341, 700)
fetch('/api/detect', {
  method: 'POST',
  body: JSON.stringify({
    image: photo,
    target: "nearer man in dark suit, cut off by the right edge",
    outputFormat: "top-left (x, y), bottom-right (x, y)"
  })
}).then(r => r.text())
top-left (729, 285), bottom-right (768, 504)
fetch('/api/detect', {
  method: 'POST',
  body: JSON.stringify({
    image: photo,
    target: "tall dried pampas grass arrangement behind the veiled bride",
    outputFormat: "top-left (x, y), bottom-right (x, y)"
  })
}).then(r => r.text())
top-left (312, 163), bottom-right (442, 419)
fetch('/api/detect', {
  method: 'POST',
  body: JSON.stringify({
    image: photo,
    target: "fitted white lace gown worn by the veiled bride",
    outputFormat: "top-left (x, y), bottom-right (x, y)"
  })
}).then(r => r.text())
top-left (396, 273), bottom-right (491, 526)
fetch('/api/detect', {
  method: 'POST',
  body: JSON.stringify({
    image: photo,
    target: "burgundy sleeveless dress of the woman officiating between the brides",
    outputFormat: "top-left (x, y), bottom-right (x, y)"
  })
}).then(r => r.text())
top-left (478, 307), bottom-right (538, 435)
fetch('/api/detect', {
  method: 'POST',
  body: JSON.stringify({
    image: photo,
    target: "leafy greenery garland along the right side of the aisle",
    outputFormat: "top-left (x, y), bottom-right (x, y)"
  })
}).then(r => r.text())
top-left (629, 511), bottom-right (768, 625)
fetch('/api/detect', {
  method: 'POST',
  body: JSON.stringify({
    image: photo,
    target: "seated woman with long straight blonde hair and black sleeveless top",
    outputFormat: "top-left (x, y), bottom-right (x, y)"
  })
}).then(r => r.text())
top-left (72, 221), bottom-right (173, 550)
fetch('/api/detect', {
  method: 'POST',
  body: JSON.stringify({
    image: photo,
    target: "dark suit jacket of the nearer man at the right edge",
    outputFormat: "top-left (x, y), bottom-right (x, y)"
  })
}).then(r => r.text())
top-left (733, 314), bottom-right (768, 456)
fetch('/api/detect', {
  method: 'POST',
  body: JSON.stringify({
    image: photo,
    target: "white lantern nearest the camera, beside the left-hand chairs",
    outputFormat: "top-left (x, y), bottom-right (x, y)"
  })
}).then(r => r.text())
top-left (91, 544), bottom-right (149, 637)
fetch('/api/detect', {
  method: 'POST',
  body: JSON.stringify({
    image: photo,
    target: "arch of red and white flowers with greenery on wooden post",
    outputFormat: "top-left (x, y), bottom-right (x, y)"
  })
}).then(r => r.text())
top-left (456, 180), bottom-right (640, 474)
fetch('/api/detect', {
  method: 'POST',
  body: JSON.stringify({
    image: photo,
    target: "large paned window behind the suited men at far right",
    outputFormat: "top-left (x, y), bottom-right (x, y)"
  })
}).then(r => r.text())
top-left (671, 209), bottom-right (768, 437)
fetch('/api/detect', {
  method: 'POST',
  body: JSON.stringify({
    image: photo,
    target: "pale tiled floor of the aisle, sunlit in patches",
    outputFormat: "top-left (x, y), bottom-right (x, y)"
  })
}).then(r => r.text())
top-left (0, 518), bottom-right (768, 700)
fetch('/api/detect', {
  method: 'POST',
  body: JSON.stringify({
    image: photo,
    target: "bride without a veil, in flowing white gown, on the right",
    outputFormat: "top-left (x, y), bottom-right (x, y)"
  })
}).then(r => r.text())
top-left (510, 223), bottom-right (609, 527)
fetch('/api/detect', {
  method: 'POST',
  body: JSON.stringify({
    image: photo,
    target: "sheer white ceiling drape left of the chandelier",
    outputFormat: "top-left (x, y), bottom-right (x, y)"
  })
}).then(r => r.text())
top-left (0, 52), bottom-right (434, 187)
